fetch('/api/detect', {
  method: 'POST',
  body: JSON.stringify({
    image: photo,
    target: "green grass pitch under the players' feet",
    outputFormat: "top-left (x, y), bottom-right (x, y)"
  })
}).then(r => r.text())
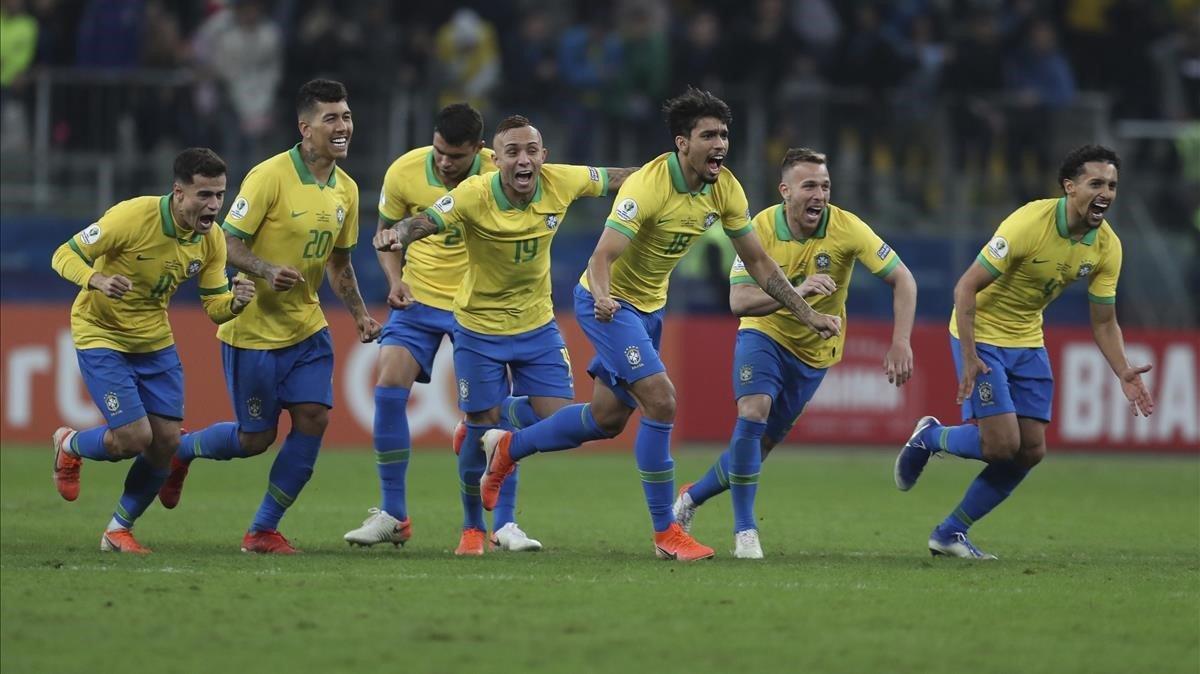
top-left (0, 443), bottom-right (1200, 674)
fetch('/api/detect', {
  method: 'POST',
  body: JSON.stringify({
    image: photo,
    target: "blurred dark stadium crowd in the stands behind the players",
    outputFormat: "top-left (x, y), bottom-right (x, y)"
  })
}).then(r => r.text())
top-left (0, 0), bottom-right (1200, 325)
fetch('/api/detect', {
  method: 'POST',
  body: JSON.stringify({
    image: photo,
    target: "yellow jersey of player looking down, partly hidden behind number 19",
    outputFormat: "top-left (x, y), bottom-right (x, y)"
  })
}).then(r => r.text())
top-left (379, 146), bottom-right (496, 311)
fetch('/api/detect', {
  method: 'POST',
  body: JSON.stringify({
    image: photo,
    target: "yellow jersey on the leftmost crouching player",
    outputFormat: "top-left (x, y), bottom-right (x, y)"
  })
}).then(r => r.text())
top-left (50, 194), bottom-right (238, 354)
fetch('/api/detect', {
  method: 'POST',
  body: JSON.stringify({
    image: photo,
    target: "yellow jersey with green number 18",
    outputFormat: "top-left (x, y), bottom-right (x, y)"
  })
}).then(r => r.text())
top-left (580, 152), bottom-right (751, 312)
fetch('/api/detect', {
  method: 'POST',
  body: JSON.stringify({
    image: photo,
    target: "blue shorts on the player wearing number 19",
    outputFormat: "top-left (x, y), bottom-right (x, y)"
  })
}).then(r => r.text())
top-left (454, 320), bottom-right (575, 414)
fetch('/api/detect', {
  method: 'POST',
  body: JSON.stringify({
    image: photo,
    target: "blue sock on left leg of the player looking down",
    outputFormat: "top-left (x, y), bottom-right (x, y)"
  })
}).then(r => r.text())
top-left (373, 386), bottom-right (413, 520)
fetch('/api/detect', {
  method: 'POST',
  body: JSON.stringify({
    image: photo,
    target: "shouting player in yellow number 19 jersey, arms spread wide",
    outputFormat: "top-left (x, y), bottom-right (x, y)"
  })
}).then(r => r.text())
top-left (374, 115), bottom-right (634, 555)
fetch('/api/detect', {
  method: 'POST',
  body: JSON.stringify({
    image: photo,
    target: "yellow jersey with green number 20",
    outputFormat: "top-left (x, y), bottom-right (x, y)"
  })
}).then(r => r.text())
top-left (217, 145), bottom-right (359, 349)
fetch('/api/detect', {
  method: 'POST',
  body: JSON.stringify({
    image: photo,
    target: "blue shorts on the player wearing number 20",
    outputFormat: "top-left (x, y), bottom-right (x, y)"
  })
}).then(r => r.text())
top-left (221, 327), bottom-right (334, 433)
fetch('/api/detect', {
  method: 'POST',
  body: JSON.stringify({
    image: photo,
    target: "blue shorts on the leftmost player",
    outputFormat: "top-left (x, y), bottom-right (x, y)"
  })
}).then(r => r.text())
top-left (76, 344), bottom-right (184, 428)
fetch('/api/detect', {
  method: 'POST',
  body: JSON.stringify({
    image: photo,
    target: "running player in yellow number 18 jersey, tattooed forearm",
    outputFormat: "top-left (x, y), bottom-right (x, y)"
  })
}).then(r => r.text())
top-left (470, 89), bottom-right (841, 561)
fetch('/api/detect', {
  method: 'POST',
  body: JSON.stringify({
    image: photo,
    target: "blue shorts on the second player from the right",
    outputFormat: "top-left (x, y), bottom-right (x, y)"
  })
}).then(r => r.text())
top-left (733, 330), bottom-right (828, 444)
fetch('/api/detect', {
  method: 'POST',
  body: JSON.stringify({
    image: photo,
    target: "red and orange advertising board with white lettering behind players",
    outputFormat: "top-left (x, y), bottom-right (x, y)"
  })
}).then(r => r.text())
top-left (0, 303), bottom-right (1200, 452)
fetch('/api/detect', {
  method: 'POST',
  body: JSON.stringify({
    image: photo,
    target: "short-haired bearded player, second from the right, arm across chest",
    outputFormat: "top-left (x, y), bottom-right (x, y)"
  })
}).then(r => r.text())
top-left (672, 148), bottom-right (917, 559)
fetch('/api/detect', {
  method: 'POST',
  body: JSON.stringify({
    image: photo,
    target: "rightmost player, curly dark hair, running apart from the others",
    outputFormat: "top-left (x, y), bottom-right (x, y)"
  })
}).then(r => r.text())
top-left (895, 145), bottom-right (1154, 559)
